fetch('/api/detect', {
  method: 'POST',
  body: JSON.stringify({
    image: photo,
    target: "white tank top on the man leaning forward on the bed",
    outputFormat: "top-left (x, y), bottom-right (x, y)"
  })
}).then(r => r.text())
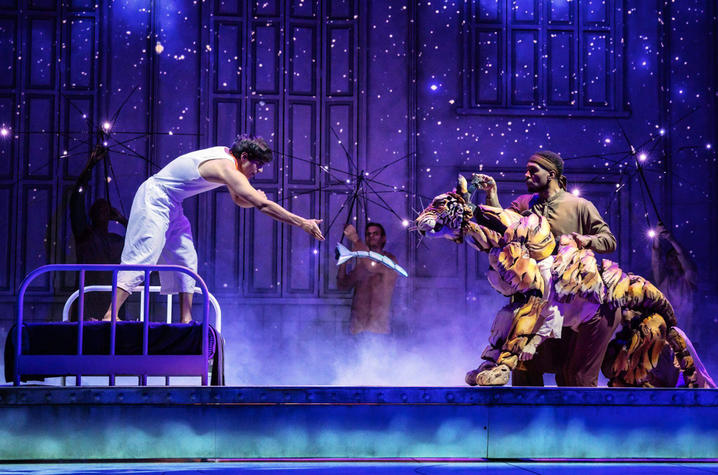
top-left (152, 146), bottom-right (237, 202)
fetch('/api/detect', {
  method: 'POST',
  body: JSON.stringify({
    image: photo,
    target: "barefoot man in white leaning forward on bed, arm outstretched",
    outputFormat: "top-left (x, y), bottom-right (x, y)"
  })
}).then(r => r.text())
top-left (103, 135), bottom-right (324, 323)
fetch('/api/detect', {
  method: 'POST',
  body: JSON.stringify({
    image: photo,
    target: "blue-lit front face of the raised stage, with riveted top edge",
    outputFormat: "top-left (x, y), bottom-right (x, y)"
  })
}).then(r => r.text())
top-left (0, 386), bottom-right (718, 462)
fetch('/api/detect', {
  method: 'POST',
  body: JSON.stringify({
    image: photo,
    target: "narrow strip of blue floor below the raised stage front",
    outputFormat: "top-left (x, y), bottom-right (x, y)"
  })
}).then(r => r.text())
top-left (0, 461), bottom-right (718, 475)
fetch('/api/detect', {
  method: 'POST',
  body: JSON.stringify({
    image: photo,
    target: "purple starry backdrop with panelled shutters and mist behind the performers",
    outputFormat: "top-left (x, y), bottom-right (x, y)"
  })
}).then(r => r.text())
top-left (0, 0), bottom-right (718, 385)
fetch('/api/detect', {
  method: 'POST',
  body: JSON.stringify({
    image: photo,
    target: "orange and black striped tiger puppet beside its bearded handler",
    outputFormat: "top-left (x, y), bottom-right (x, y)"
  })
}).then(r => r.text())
top-left (411, 174), bottom-right (715, 387)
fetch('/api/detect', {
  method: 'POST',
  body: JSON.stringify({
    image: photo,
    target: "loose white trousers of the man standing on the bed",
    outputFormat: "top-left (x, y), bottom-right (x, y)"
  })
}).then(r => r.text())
top-left (117, 178), bottom-right (197, 294)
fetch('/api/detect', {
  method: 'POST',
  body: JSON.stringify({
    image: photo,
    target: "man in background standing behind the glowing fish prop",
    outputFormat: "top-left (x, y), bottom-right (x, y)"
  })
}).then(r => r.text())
top-left (337, 223), bottom-right (397, 335)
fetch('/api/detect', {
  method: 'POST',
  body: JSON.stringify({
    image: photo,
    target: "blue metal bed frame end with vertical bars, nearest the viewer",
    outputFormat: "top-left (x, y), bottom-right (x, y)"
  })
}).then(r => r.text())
top-left (14, 264), bottom-right (210, 386)
